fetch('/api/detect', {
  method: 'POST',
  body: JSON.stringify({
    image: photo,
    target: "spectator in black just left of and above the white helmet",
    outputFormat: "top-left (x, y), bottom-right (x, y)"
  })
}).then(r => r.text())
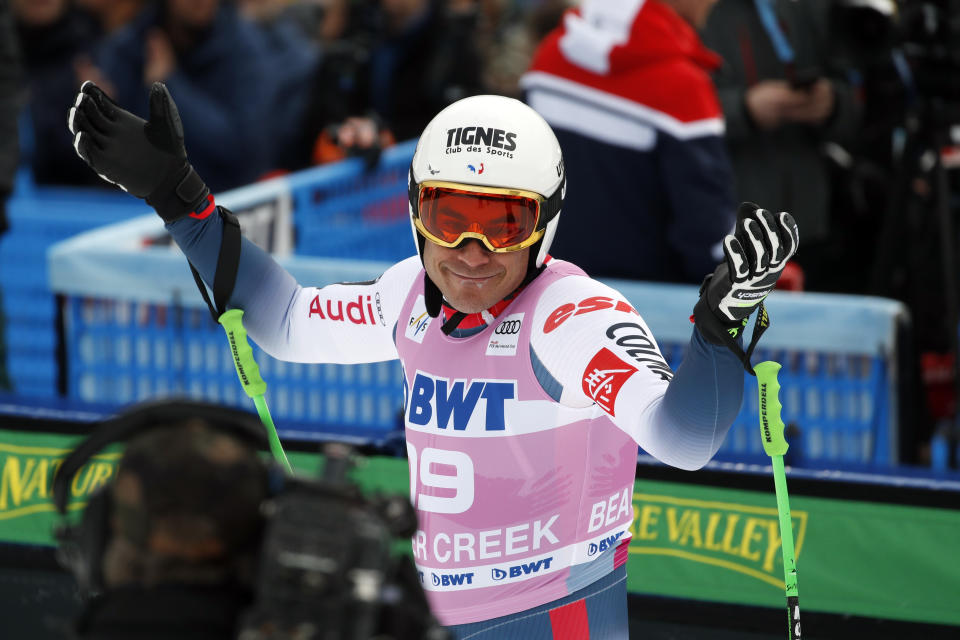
top-left (300, 0), bottom-right (480, 168)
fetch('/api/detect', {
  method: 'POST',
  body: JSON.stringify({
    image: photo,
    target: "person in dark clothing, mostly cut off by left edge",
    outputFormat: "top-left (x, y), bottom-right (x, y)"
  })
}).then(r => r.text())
top-left (0, 2), bottom-right (20, 390)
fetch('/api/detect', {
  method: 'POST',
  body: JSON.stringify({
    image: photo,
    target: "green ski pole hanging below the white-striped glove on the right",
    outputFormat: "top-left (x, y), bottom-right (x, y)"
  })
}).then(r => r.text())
top-left (753, 361), bottom-right (800, 640)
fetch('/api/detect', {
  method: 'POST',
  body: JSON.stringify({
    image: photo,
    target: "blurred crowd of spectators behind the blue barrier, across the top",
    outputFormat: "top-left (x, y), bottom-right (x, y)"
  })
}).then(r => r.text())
top-left (0, 0), bottom-right (960, 462)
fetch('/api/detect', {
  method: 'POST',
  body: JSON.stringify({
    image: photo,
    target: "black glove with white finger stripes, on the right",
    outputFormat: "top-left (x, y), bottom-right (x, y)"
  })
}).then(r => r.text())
top-left (693, 202), bottom-right (800, 362)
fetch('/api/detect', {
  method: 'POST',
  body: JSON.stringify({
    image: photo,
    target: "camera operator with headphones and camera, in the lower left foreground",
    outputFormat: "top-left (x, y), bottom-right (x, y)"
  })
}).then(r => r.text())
top-left (54, 401), bottom-right (444, 640)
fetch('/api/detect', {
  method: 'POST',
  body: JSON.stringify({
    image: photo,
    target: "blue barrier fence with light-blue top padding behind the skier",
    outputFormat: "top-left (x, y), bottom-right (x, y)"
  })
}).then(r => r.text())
top-left (50, 143), bottom-right (905, 465)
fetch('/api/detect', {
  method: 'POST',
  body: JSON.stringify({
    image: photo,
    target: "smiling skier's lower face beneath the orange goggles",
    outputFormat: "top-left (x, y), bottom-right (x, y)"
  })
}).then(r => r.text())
top-left (423, 240), bottom-right (530, 313)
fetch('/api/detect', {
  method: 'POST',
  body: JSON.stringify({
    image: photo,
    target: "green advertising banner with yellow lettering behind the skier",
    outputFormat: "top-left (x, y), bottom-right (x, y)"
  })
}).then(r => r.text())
top-left (0, 431), bottom-right (960, 625)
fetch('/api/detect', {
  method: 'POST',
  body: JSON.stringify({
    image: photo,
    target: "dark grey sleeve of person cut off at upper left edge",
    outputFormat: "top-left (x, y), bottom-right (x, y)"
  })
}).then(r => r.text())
top-left (0, 0), bottom-right (20, 195)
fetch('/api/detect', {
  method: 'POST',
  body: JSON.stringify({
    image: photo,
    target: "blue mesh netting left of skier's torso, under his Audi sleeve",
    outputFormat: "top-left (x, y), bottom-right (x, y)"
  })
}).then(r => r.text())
top-left (66, 297), bottom-right (403, 434)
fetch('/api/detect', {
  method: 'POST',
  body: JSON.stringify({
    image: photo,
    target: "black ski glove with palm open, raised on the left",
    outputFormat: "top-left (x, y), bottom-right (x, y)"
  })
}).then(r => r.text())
top-left (68, 81), bottom-right (213, 222)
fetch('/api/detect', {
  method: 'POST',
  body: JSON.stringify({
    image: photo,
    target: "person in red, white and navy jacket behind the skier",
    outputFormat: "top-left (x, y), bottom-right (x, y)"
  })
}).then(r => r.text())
top-left (521, 0), bottom-right (735, 283)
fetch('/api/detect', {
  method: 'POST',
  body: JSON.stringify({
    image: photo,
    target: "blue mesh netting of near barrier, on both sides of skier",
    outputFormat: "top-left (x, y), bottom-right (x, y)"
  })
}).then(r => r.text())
top-left (67, 298), bottom-right (890, 464)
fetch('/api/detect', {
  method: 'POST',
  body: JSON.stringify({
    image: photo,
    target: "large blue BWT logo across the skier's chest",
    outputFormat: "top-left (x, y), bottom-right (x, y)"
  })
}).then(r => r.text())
top-left (407, 371), bottom-right (517, 431)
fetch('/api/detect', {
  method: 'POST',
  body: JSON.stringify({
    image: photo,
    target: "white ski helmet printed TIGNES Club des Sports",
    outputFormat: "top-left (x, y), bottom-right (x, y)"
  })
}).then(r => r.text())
top-left (408, 95), bottom-right (566, 271)
